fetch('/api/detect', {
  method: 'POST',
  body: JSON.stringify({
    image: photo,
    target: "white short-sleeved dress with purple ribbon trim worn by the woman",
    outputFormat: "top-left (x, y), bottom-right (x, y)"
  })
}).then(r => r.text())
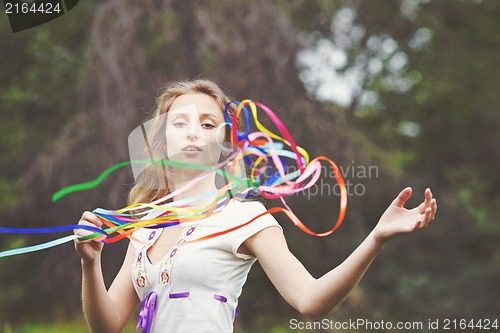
top-left (132, 200), bottom-right (281, 333)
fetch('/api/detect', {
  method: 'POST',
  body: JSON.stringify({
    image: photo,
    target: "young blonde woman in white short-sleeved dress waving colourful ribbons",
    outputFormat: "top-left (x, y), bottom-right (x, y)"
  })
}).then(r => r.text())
top-left (75, 80), bottom-right (437, 333)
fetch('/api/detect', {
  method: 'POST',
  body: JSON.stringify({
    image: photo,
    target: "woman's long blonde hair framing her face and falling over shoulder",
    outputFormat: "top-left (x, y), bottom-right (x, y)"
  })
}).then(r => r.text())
top-left (128, 79), bottom-right (241, 205)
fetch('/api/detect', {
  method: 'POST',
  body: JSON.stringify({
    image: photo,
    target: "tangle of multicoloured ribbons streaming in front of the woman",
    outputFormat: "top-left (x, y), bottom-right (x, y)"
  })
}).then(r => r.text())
top-left (0, 100), bottom-right (347, 257)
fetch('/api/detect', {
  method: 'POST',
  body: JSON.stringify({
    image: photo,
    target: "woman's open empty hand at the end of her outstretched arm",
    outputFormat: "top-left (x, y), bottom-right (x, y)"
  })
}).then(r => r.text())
top-left (373, 187), bottom-right (437, 245)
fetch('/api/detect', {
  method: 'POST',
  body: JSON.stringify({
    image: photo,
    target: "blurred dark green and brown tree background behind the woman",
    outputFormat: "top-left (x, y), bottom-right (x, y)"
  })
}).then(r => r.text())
top-left (0, 0), bottom-right (500, 332)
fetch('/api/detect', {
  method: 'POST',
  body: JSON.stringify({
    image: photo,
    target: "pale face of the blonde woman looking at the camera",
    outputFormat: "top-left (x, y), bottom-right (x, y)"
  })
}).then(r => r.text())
top-left (165, 93), bottom-right (224, 165)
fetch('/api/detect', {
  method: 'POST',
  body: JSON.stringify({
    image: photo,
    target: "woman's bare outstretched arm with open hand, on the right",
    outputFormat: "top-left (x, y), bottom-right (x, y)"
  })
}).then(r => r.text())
top-left (244, 188), bottom-right (437, 319)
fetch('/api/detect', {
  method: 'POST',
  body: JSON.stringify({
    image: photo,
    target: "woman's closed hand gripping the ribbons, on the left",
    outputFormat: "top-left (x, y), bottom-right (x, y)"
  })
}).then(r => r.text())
top-left (74, 211), bottom-right (104, 264)
